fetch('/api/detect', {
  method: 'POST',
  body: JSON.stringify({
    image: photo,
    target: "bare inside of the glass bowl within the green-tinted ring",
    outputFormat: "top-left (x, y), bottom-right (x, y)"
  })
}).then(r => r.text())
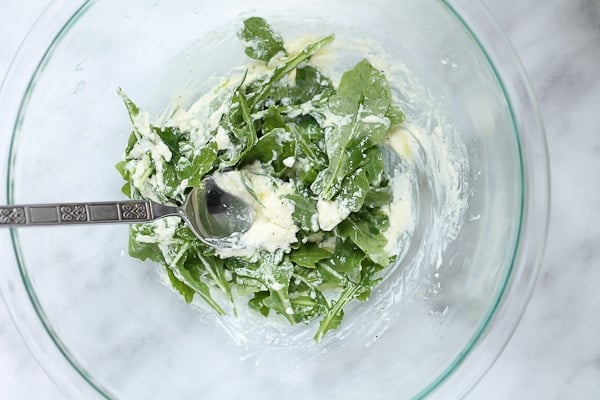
top-left (9, 0), bottom-right (523, 399)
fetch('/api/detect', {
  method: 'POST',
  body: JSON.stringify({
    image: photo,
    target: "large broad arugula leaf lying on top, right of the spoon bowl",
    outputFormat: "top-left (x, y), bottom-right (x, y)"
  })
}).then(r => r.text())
top-left (311, 60), bottom-right (391, 200)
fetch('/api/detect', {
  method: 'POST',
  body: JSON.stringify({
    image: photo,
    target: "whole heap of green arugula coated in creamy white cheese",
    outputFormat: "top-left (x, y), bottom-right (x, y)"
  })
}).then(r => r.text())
top-left (116, 17), bottom-right (405, 341)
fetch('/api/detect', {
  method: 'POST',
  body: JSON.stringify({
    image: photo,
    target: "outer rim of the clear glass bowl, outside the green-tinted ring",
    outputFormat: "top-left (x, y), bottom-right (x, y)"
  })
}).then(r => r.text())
top-left (0, 0), bottom-right (550, 399)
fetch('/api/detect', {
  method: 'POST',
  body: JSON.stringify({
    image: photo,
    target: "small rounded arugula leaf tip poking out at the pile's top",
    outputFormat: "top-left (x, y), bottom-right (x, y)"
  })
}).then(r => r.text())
top-left (240, 17), bottom-right (287, 62)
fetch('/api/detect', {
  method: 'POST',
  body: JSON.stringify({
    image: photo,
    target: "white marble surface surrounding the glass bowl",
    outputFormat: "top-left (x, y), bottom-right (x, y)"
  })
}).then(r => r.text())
top-left (0, 0), bottom-right (600, 400)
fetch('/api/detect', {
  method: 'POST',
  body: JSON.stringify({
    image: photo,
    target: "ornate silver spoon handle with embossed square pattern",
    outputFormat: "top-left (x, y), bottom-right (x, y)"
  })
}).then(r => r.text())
top-left (0, 200), bottom-right (180, 226)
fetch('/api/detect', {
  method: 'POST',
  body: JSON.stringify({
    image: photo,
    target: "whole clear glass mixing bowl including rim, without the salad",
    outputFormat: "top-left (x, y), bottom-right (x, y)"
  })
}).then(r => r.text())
top-left (0, 0), bottom-right (548, 399)
